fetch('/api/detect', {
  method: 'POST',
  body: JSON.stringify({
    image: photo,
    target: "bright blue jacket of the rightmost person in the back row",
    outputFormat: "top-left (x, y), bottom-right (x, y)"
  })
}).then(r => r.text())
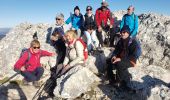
top-left (120, 13), bottom-right (138, 37)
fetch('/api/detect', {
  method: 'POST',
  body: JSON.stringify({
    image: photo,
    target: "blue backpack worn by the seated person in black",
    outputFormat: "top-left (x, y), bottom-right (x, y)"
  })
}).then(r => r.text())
top-left (128, 39), bottom-right (142, 59)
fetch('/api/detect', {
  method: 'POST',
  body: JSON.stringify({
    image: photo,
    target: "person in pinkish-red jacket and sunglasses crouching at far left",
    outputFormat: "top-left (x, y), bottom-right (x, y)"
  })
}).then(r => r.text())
top-left (14, 40), bottom-right (55, 86)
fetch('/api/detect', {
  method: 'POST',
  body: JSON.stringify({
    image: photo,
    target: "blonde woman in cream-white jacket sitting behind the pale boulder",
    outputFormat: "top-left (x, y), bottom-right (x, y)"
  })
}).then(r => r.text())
top-left (56, 30), bottom-right (84, 75)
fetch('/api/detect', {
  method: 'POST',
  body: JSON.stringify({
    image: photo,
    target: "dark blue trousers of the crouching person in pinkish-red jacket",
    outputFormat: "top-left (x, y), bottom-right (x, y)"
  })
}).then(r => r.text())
top-left (21, 67), bottom-right (44, 82)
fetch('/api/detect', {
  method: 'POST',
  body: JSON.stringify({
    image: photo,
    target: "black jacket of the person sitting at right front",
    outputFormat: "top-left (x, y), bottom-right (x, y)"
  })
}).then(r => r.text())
top-left (112, 38), bottom-right (137, 66)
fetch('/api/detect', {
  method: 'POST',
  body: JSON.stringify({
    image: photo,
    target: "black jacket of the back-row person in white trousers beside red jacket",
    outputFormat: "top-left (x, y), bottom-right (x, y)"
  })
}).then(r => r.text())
top-left (84, 14), bottom-right (96, 30)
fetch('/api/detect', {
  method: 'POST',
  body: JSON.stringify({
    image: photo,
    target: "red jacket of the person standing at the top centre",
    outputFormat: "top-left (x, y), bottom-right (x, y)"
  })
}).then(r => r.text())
top-left (95, 8), bottom-right (114, 27)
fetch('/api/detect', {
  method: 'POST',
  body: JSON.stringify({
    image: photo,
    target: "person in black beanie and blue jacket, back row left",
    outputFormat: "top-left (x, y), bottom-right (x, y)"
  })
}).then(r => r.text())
top-left (66, 6), bottom-right (84, 37)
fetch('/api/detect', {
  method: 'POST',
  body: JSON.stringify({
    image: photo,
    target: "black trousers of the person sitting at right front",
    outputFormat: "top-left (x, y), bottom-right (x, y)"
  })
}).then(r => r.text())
top-left (107, 59), bottom-right (132, 82)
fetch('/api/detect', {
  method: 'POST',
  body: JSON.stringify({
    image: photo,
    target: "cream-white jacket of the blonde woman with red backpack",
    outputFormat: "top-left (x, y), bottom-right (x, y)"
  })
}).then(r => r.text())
top-left (63, 39), bottom-right (84, 67)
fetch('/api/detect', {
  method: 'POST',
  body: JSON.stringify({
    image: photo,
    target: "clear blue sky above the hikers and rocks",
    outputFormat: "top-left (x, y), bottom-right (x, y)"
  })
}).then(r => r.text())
top-left (0, 0), bottom-right (170, 27)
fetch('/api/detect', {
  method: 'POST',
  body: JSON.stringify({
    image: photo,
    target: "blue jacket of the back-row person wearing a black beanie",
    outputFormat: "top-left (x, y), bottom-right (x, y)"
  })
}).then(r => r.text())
top-left (66, 14), bottom-right (84, 30)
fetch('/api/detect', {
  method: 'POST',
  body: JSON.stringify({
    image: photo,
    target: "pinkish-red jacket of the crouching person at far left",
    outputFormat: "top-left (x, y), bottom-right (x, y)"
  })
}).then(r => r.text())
top-left (14, 49), bottom-right (52, 72)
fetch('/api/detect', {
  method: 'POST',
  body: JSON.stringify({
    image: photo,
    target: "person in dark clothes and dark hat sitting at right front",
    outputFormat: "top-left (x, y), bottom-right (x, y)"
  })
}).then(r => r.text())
top-left (107, 25), bottom-right (138, 87)
